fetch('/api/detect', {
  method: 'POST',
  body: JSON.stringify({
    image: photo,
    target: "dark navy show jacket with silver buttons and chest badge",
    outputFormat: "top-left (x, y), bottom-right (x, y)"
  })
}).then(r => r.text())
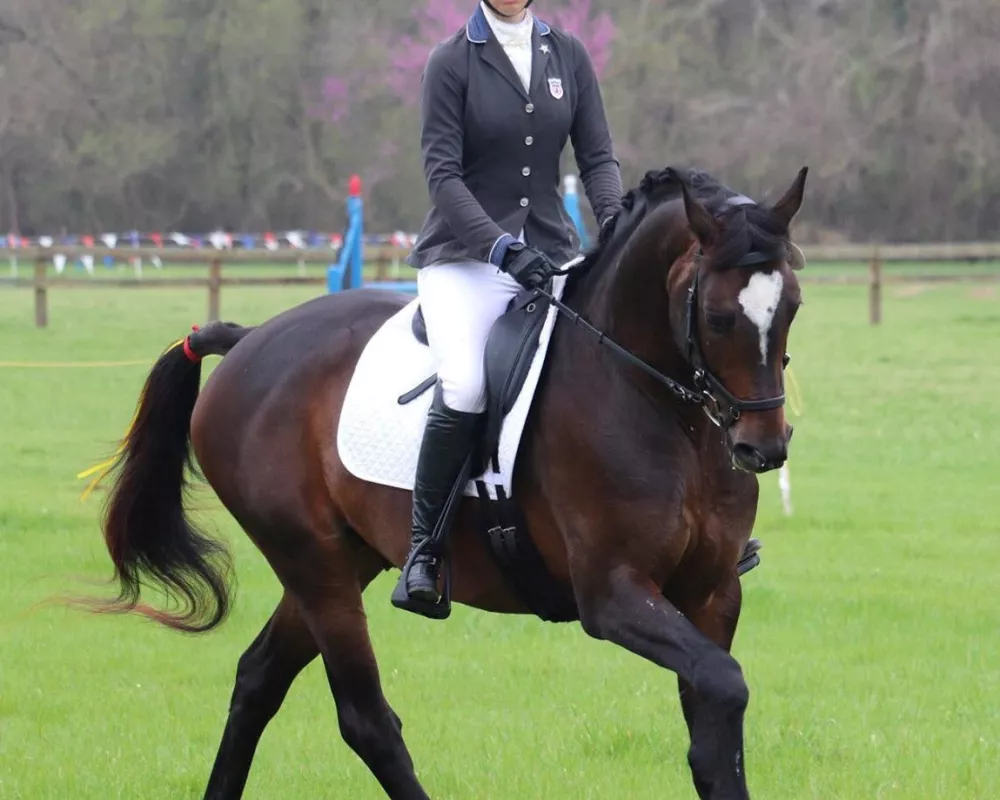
top-left (407, 6), bottom-right (622, 268)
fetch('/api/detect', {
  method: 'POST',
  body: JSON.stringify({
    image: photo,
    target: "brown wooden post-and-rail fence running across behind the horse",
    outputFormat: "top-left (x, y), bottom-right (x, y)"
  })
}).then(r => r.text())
top-left (0, 242), bottom-right (1000, 327)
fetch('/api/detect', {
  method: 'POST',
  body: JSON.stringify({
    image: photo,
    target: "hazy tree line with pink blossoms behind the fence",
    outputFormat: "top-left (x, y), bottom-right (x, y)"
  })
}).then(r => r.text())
top-left (0, 0), bottom-right (1000, 241)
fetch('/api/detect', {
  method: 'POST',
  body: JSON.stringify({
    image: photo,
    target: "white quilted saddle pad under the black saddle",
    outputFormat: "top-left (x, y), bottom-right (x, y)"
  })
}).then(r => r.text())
top-left (337, 276), bottom-right (574, 497)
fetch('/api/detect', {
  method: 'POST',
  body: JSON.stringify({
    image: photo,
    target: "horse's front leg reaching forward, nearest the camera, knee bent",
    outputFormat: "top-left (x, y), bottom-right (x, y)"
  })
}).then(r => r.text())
top-left (575, 566), bottom-right (750, 800)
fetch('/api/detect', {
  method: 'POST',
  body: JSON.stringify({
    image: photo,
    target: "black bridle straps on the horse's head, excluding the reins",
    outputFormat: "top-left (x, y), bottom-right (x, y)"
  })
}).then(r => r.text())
top-left (684, 255), bottom-right (790, 430)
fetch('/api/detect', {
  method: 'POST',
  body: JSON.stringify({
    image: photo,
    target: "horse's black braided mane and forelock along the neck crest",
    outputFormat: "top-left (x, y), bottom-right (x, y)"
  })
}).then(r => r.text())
top-left (566, 167), bottom-right (788, 291)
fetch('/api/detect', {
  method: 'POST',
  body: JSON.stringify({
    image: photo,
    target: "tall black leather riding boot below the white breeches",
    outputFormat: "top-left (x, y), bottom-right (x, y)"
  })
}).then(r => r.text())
top-left (392, 383), bottom-right (484, 618)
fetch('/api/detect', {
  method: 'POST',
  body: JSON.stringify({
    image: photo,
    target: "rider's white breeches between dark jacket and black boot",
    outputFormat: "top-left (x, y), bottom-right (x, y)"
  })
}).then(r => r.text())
top-left (417, 261), bottom-right (521, 412)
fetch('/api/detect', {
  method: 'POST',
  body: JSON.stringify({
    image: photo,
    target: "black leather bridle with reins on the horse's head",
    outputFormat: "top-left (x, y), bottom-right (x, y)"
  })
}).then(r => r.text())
top-left (537, 248), bottom-right (791, 430)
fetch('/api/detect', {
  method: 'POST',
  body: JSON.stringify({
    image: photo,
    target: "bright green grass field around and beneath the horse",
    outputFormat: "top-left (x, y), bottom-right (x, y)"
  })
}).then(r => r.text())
top-left (0, 276), bottom-right (1000, 800)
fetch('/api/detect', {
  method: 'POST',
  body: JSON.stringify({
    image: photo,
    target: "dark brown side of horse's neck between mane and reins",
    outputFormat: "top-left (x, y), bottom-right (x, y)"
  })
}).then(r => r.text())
top-left (584, 200), bottom-right (692, 381)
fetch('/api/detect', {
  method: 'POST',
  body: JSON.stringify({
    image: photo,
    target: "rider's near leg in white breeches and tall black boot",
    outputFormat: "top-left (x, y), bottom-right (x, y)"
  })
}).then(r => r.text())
top-left (394, 261), bottom-right (520, 612)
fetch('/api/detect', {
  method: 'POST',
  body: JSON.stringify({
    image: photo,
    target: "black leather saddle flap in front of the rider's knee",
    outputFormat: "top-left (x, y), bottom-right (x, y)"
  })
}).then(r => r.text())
top-left (482, 290), bottom-right (550, 469)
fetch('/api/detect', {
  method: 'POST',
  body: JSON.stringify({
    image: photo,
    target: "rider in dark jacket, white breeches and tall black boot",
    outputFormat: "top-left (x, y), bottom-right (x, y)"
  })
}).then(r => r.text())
top-left (393, 0), bottom-right (622, 616)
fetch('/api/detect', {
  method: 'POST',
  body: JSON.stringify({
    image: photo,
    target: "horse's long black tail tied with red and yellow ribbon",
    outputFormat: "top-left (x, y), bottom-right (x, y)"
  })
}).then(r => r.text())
top-left (88, 322), bottom-right (251, 633)
